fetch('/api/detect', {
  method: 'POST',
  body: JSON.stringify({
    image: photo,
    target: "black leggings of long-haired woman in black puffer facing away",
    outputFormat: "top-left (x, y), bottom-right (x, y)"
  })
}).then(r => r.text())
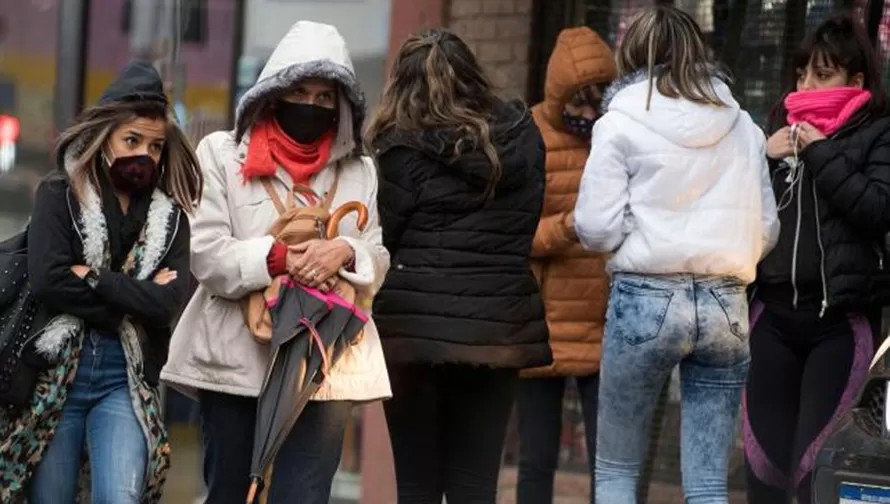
top-left (384, 364), bottom-right (519, 504)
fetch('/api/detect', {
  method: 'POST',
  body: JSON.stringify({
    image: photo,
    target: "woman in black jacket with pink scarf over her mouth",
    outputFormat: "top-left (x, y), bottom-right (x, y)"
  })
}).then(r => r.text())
top-left (744, 15), bottom-right (890, 504)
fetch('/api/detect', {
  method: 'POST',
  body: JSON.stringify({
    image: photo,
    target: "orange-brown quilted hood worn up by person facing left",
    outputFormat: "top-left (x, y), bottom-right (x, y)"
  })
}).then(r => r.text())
top-left (541, 27), bottom-right (616, 131)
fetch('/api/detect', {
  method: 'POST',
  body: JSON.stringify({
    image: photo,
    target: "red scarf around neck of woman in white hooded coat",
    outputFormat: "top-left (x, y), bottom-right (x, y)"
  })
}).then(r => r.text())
top-left (241, 119), bottom-right (334, 184)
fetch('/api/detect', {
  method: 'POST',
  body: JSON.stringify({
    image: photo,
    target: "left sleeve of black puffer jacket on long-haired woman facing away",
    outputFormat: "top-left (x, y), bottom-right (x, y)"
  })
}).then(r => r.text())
top-left (377, 147), bottom-right (420, 257)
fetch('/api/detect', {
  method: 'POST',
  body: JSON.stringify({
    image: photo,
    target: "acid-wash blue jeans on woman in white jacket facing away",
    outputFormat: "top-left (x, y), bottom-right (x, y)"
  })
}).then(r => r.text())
top-left (596, 274), bottom-right (750, 504)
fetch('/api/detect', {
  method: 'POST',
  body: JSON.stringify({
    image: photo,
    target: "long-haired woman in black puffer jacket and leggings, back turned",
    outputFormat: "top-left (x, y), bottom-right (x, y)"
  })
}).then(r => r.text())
top-left (367, 29), bottom-right (551, 504)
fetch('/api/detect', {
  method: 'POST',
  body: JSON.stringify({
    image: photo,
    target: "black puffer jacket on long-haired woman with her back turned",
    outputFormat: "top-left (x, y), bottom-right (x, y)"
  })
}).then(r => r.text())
top-left (374, 100), bottom-right (552, 368)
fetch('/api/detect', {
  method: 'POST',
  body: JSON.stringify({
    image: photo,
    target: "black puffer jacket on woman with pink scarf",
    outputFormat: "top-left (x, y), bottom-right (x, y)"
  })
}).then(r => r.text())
top-left (757, 117), bottom-right (890, 309)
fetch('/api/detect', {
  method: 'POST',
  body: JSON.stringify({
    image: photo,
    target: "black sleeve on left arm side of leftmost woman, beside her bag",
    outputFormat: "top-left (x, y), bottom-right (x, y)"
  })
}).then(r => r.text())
top-left (28, 179), bottom-right (123, 330)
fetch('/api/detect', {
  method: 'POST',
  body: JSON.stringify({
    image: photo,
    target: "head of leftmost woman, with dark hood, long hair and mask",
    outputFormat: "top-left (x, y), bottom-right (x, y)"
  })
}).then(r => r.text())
top-left (56, 61), bottom-right (203, 211)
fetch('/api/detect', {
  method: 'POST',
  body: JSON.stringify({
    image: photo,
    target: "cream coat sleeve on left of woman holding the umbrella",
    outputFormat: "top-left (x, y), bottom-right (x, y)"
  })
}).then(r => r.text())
top-left (191, 132), bottom-right (274, 299)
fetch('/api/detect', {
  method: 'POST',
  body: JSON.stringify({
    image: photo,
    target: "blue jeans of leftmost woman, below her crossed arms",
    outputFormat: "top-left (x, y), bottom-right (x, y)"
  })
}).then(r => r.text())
top-left (28, 332), bottom-right (148, 504)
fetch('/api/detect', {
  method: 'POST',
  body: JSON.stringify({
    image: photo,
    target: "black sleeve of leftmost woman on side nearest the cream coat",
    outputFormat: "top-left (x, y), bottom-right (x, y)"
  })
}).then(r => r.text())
top-left (96, 212), bottom-right (190, 327)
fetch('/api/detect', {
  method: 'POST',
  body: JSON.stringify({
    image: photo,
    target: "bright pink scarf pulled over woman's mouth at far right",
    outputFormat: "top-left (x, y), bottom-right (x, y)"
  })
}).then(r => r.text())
top-left (785, 87), bottom-right (871, 135)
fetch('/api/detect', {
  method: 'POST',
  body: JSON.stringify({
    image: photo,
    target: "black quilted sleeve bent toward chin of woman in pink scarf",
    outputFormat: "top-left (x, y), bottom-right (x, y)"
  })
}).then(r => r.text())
top-left (801, 126), bottom-right (890, 237)
